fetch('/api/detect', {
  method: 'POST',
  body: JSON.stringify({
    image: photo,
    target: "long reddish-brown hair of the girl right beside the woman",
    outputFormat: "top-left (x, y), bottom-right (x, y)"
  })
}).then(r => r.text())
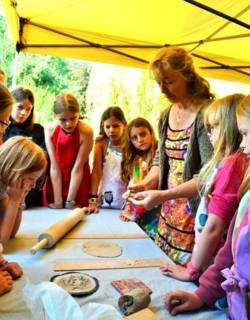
top-left (121, 117), bottom-right (157, 183)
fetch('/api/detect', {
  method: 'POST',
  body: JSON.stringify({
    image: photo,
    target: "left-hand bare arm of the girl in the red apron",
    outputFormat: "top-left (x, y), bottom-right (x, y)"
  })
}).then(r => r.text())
top-left (44, 122), bottom-right (63, 209)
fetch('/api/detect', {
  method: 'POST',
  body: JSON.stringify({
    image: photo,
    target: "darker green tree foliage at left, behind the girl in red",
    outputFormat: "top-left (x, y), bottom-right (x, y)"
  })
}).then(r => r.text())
top-left (0, 4), bottom-right (91, 124)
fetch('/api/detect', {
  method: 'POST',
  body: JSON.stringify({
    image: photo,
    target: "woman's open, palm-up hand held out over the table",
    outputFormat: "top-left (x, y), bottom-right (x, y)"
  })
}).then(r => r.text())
top-left (128, 190), bottom-right (162, 210)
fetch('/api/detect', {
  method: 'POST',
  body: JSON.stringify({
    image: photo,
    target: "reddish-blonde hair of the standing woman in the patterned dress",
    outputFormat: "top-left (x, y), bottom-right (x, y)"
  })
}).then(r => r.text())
top-left (149, 46), bottom-right (215, 111)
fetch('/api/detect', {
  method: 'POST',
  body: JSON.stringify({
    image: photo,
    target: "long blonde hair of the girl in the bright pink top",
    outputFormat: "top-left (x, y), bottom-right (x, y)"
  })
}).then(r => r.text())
top-left (199, 93), bottom-right (245, 190)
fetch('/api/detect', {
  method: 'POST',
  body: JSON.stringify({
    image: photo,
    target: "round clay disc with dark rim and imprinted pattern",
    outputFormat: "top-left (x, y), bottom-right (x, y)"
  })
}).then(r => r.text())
top-left (50, 272), bottom-right (99, 296)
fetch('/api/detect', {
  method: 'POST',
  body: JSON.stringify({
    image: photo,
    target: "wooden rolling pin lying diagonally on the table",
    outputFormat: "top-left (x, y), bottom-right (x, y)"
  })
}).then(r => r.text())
top-left (30, 208), bottom-right (86, 254)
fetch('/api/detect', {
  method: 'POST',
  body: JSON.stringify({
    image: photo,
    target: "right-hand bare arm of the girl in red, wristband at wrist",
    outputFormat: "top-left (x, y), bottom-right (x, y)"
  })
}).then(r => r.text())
top-left (65, 123), bottom-right (93, 209)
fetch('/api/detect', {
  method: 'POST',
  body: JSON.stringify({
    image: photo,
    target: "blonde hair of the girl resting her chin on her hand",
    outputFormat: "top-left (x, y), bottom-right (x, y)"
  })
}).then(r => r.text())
top-left (0, 136), bottom-right (47, 186)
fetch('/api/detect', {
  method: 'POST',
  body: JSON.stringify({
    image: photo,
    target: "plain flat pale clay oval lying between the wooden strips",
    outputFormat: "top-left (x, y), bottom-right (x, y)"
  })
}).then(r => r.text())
top-left (82, 241), bottom-right (122, 258)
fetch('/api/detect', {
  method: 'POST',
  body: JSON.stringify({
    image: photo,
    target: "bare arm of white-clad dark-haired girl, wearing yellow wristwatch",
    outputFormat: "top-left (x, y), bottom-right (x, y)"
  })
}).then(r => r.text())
top-left (88, 138), bottom-right (107, 213)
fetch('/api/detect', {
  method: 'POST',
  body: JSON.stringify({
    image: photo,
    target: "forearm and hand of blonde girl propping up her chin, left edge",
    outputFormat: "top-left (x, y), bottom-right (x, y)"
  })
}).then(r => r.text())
top-left (0, 177), bottom-right (29, 247)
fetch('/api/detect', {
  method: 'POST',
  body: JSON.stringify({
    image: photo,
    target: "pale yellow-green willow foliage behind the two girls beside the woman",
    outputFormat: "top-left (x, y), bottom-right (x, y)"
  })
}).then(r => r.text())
top-left (86, 63), bottom-right (168, 135)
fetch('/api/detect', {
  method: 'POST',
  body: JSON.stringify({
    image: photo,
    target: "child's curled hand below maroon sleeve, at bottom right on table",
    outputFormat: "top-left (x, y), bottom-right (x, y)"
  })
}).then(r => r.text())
top-left (164, 290), bottom-right (204, 316)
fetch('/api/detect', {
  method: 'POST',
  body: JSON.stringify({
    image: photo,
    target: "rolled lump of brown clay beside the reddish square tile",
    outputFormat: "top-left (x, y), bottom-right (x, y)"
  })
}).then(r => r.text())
top-left (118, 289), bottom-right (151, 316)
